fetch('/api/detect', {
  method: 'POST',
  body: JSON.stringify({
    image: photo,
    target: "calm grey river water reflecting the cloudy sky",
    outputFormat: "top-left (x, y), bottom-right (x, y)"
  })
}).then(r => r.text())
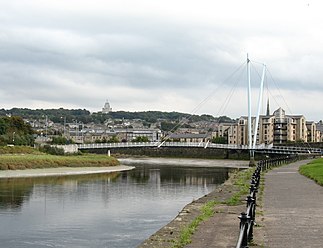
top-left (0, 159), bottom-right (247, 248)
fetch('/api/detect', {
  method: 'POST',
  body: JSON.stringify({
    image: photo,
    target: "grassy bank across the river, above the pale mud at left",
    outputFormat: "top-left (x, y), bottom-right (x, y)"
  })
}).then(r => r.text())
top-left (0, 147), bottom-right (119, 170)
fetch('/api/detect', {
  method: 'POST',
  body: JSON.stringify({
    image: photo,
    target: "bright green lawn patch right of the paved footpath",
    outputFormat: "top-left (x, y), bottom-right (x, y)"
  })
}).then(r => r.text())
top-left (299, 158), bottom-right (323, 186)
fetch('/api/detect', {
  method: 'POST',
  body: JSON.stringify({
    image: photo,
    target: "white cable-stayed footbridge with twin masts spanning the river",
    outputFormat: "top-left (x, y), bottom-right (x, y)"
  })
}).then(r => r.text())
top-left (69, 56), bottom-right (322, 159)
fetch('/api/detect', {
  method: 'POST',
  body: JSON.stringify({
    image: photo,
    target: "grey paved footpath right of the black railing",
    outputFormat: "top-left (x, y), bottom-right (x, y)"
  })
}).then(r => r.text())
top-left (264, 160), bottom-right (323, 248)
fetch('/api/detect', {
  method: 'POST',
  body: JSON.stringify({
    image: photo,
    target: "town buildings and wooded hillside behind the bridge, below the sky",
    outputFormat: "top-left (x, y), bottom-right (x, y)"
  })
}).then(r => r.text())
top-left (0, 101), bottom-right (323, 145)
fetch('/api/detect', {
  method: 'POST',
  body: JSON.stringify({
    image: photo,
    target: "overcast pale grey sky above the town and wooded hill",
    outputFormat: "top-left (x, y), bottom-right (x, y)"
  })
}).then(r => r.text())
top-left (0, 0), bottom-right (323, 121)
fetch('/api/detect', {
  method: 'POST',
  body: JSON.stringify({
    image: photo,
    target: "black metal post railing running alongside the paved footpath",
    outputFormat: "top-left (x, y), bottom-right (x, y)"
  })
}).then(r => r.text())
top-left (236, 155), bottom-right (298, 248)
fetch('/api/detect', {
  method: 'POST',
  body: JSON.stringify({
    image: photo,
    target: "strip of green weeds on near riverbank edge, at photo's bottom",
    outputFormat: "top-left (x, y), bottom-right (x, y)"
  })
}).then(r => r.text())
top-left (172, 201), bottom-right (219, 248)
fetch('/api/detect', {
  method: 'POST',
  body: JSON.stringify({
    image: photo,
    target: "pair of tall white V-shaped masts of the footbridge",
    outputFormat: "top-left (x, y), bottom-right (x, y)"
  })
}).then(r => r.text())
top-left (247, 55), bottom-right (266, 159)
